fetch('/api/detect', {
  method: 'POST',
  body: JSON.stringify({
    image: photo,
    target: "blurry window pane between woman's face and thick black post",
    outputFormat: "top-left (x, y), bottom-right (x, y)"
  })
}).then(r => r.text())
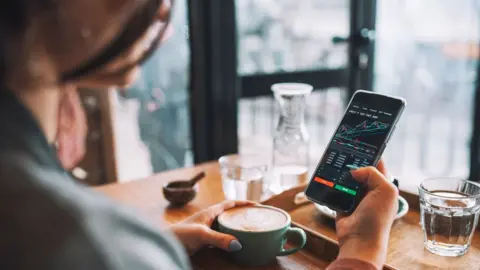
top-left (116, 0), bottom-right (192, 180)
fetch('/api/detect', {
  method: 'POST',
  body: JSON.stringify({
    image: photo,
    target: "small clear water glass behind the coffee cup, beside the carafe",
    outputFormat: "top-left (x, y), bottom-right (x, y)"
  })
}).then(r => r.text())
top-left (218, 155), bottom-right (267, 201)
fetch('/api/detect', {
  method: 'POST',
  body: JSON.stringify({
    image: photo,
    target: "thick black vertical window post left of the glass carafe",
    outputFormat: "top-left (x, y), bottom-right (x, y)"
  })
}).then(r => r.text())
top-left (188, 0), bottom-right (240, 163)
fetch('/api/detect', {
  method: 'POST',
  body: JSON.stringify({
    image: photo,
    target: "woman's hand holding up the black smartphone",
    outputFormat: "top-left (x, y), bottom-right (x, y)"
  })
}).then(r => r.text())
top-left (337, 162), bottom-right (398, 269)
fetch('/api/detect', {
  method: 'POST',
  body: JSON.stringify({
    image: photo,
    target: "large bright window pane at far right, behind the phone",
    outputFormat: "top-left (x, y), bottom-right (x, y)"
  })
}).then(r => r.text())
top-left (375, 0), bottom-right (480, 190)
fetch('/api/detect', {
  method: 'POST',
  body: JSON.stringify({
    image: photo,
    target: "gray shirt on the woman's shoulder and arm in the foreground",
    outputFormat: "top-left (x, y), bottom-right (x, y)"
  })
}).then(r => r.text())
top-left (0, 91), bottom-right (190, 270)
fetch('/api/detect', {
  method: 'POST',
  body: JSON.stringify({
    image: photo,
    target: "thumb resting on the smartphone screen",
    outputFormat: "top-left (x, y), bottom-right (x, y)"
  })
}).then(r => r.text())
top-left (351, 167), bottom-right (397, 193)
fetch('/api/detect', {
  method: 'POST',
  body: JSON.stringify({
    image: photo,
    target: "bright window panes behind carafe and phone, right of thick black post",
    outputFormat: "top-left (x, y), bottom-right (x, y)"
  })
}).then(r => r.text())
top-left (233, 0), bottom-right (480, 191)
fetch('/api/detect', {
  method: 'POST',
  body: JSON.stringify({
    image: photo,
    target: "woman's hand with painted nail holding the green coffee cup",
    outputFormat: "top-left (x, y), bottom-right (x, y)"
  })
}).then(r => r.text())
top-left (170, 201), bottom-right (255, 255)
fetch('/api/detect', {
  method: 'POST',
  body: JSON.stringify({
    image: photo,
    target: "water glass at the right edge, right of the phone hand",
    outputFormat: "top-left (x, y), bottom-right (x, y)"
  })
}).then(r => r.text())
top-left (418, 178), bottom-right (480, 257)
